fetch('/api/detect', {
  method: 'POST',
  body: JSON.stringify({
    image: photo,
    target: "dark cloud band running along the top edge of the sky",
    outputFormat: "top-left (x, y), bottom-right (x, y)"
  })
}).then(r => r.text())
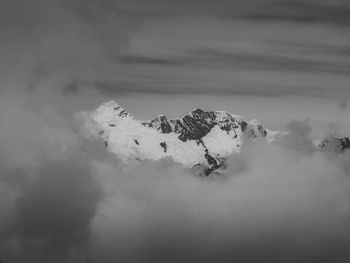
top-left (66, 0), bottom-right (350, 25)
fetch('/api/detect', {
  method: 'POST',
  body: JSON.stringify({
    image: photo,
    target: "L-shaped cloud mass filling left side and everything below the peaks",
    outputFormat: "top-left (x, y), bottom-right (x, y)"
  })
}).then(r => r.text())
top-left (0, 1), bottom-right (350, 263)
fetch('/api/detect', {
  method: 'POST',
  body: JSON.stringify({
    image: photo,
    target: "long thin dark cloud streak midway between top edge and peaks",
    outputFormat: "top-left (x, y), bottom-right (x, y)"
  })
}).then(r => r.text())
top-left (119, 50), bottom-right (350, 74)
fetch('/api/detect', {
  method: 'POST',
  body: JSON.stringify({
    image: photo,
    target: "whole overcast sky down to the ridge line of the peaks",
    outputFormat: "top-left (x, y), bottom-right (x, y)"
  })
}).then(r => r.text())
top-left (0, 0), bottom-right (350, 136)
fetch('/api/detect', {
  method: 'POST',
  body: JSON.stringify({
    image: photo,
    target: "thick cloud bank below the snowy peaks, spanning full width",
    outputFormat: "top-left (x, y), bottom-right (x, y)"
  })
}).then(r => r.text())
top-left (0, 79), bottom-right (350, 262)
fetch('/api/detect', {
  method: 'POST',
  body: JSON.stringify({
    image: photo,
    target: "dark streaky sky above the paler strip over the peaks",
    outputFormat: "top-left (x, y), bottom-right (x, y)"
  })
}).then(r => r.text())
top-left (0, 0), bottom-right (350, 98)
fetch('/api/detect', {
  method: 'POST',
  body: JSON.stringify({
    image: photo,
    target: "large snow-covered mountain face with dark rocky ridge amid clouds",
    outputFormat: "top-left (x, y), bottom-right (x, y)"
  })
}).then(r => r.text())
top-left (79, 101), bottom-right (280, 174)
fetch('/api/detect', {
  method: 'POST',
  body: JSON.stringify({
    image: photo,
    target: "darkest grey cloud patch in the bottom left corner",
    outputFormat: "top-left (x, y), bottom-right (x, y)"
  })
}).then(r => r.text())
top-left (3, 159), bottom-right (100, 262)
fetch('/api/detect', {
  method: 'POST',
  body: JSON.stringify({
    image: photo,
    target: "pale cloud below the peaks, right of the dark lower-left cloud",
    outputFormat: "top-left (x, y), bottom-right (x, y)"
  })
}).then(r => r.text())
top-left (85, 134), bottom-right (350, 262)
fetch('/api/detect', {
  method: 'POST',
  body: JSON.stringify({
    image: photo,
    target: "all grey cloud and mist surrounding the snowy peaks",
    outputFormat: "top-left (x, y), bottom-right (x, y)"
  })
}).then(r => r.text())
top-left (0, 0), bottom-right (350, 263)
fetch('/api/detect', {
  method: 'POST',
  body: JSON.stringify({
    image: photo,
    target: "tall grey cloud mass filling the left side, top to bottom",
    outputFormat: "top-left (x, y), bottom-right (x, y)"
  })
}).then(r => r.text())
top-left (0, 1), bottom-right (110, 263)
